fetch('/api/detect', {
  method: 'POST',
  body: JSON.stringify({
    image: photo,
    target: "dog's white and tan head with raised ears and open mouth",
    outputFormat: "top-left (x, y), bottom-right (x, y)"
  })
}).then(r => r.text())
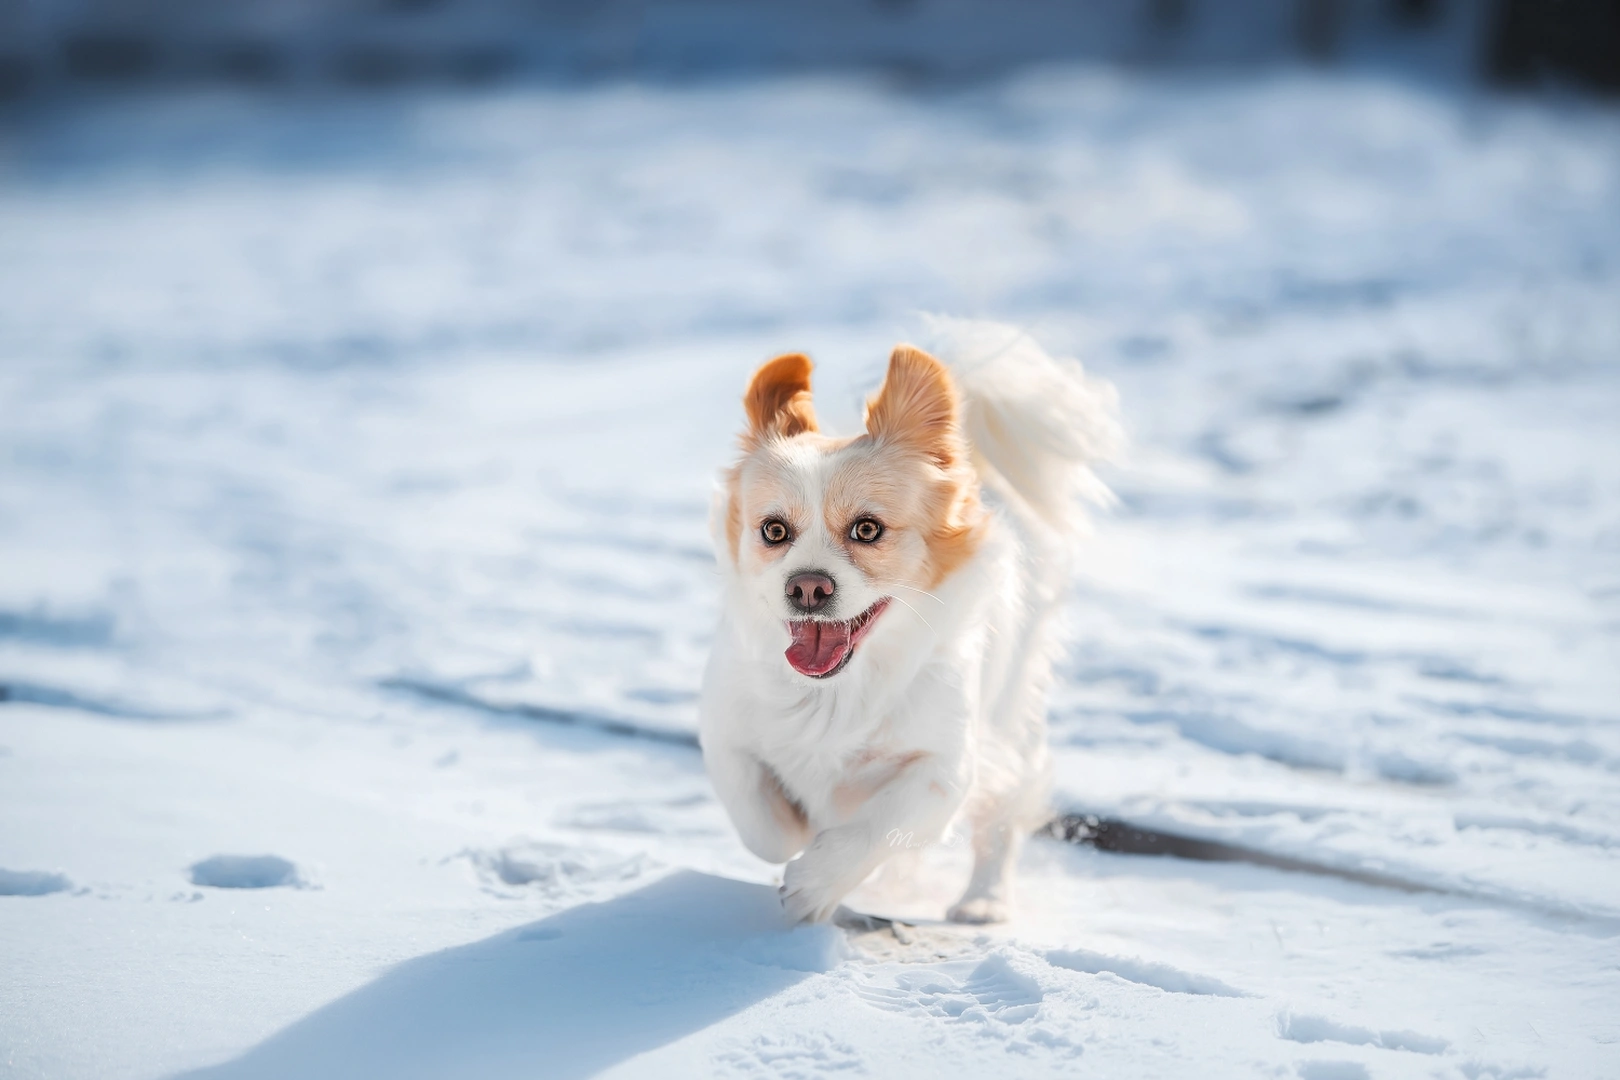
top-left (714, 345), bottom-right (985, 678)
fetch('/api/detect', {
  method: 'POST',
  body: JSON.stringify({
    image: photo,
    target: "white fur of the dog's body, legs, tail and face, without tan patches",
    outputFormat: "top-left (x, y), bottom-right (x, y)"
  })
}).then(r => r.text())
top-left (700, 319), bottom-right (1119, 921)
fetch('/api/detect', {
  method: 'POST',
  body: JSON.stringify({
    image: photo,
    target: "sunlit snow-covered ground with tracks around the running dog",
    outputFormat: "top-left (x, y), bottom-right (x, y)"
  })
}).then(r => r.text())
top-left (0, 71), bottom-right (1620, 1080)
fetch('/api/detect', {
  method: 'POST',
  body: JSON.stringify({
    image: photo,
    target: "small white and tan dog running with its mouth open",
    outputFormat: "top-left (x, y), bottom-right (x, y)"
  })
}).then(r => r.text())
top-left (700, 321), bottom-right (1119, 923)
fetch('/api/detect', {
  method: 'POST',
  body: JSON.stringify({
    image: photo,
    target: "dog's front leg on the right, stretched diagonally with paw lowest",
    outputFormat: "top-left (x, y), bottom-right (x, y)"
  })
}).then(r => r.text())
top-left (782, 753), bottom-right (967, 923)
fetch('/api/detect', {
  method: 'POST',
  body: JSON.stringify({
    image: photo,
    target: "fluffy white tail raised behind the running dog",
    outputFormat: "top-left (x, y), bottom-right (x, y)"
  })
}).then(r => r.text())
top-left (930, 317), bottom-right (1124, 538)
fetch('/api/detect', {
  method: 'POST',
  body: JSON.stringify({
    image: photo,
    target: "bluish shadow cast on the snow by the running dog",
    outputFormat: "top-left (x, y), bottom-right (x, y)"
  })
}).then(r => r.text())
top-left (178, 873), bottom-right (841, 1080)
